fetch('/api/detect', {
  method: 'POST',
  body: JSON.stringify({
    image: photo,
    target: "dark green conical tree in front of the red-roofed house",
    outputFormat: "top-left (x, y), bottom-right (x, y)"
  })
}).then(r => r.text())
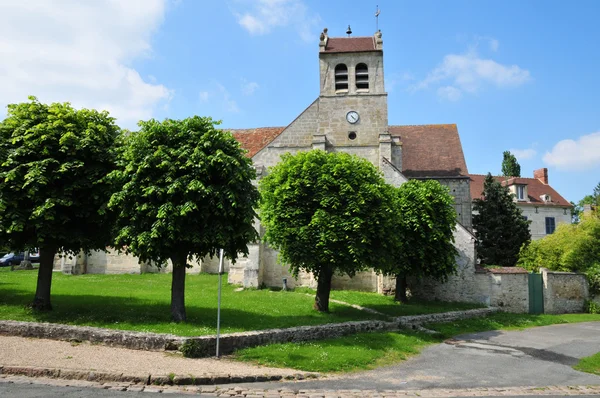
top-left (473, 173), bottom-right (531, 267)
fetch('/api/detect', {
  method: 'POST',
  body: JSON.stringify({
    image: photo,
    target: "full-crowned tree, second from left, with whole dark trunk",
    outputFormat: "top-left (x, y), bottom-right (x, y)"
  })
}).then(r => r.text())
top-left (109, 116), bottom-right (259, 322)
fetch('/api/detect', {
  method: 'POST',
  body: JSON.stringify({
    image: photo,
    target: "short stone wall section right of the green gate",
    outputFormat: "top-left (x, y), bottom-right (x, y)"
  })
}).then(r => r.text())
top-left (540, 268), bottom-right (589, 314)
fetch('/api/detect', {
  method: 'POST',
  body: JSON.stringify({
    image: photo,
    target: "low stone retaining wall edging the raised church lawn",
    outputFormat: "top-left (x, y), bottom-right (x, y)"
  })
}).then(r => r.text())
top-left (0, 308), bottom-right (498, 358)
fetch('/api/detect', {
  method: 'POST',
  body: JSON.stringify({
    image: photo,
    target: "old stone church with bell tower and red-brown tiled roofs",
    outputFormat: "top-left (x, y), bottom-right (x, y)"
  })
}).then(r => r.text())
top-left (55, 29), bottom-right (482, 301)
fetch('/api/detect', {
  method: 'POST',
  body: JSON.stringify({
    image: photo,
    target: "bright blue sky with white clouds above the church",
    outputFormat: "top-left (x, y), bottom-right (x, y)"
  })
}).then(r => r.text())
top-left (0, 0), bottom-right (600, 201)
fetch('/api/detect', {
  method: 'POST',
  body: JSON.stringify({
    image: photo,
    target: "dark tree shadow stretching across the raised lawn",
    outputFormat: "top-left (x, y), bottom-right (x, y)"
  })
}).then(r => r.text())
top-left (0, 284), bottom-right (380, 336)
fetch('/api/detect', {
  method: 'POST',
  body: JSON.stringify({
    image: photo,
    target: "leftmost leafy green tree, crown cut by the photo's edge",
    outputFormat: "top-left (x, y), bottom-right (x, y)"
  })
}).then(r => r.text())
top-left (0, 97), bottom-right (120, 310)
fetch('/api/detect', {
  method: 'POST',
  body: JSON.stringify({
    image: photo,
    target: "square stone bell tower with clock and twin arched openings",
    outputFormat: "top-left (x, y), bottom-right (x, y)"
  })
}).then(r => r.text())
top-left (316, 27), bottom-right (390, 166)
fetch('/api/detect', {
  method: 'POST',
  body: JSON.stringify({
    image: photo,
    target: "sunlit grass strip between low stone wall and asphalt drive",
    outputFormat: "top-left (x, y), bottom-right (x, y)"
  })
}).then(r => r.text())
top-left (234, 313), bottom-right (600, 372)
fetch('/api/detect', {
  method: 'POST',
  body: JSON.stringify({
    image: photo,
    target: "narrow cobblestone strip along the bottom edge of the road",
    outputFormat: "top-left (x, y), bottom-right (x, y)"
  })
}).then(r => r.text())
top-left (0, 375), bottom-right (600, 398)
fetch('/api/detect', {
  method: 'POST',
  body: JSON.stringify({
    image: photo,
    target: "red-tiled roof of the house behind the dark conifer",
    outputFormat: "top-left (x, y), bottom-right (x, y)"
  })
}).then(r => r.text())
top-left (469, 174), bottom-right (571, 207)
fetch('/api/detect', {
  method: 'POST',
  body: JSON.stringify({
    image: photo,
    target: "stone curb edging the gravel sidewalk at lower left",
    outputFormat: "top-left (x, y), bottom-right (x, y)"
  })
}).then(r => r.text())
top-left (0, 365), bottom-right (321, 386)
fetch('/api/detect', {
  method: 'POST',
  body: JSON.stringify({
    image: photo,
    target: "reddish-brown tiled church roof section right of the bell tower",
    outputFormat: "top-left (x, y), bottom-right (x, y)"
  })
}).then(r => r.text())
top-left (389, 124), bottom-right (469, 178)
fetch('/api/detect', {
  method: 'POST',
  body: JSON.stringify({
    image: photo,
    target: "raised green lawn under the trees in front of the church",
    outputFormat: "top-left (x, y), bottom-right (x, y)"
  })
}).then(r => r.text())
top-left (0, 268), bottom-right (476, 336)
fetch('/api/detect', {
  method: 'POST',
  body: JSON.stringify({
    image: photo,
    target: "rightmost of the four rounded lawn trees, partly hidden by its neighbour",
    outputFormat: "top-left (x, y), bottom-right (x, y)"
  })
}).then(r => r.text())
top-left (378, 180), bottom-right (458, 302)
